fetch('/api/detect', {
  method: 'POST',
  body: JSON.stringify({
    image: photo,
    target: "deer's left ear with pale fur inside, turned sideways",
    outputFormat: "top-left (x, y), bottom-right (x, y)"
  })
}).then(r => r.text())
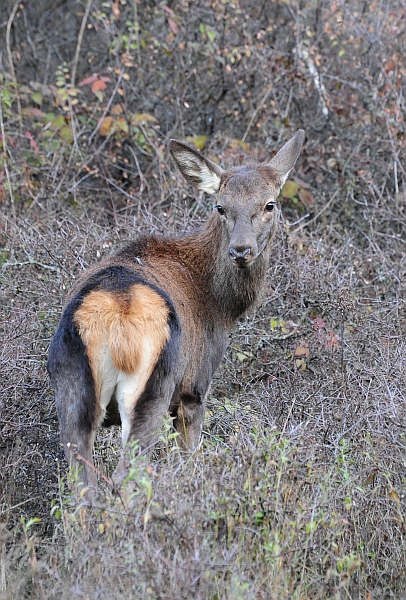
top-left (169, 140), bottom-right (223, 194)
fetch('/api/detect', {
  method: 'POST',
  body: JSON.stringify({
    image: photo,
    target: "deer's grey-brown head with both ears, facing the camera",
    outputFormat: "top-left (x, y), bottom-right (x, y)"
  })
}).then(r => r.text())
top-left (170, 129), bottom-right (305, 269)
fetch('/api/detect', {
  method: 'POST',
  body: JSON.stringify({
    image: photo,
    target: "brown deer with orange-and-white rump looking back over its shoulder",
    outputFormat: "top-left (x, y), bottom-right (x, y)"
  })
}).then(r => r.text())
top-left (47, 130), bottom-right (305, 495)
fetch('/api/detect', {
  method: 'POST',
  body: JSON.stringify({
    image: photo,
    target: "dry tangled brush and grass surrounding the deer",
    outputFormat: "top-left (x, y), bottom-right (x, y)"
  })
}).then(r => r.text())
top-left (0, 0), bottom-right (406, 600)
